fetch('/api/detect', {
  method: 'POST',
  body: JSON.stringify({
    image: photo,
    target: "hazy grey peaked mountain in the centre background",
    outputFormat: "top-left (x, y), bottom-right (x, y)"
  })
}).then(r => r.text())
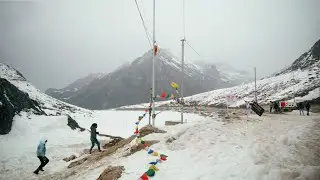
top-left (47, 49), bottom-right (231, 109)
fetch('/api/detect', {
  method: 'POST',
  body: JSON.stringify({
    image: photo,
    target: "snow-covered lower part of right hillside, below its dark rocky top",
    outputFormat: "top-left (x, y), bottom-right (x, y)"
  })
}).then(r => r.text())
top-left (181, 68), bottom-right (320, 106)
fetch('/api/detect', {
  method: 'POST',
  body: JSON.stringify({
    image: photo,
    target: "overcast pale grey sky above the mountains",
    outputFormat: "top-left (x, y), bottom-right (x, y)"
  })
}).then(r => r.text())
top-left (0, 0), bottom-right (320, 90)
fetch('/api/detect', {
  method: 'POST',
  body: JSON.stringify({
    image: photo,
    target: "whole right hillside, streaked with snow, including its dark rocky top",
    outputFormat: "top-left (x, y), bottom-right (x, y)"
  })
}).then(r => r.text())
top-left (185, 40), bottom-right (320, 106)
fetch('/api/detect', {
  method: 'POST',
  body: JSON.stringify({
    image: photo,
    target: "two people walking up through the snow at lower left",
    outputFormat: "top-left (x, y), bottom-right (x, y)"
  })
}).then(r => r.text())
top-left (33, 123), bottom-right (101, 174)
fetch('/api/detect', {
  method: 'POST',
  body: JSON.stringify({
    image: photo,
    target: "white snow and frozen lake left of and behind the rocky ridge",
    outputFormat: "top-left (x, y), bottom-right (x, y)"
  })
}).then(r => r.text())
top-left (0, 111), bottom-right (201, 179)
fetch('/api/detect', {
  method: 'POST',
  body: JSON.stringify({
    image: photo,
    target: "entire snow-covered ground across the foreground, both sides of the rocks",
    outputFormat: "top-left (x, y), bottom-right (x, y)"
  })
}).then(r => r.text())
top-left (0, 111), bottom-right (320, 180)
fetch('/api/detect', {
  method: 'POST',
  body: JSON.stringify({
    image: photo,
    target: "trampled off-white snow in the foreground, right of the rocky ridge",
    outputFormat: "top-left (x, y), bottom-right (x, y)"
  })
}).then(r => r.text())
top-left (119, 112), bottom-right (320, 180)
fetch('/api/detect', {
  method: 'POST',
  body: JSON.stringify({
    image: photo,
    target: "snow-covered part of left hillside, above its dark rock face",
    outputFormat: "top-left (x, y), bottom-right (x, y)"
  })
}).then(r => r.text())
top-left (0, 63), bottom-right (90, 115)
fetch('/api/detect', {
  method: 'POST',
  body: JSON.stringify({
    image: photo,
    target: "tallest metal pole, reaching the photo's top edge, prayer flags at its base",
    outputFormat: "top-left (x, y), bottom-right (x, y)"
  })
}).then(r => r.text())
top-left (152, 0), bottom-right (156, 127)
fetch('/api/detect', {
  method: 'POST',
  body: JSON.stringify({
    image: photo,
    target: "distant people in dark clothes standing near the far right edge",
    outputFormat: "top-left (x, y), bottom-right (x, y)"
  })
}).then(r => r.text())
top-left (270, 101), bottom-right (311, 116)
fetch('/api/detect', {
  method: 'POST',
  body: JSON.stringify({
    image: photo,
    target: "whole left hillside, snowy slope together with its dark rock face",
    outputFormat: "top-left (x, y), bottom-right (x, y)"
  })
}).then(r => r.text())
top-left (0, 63), bottom-right (91, 134)
